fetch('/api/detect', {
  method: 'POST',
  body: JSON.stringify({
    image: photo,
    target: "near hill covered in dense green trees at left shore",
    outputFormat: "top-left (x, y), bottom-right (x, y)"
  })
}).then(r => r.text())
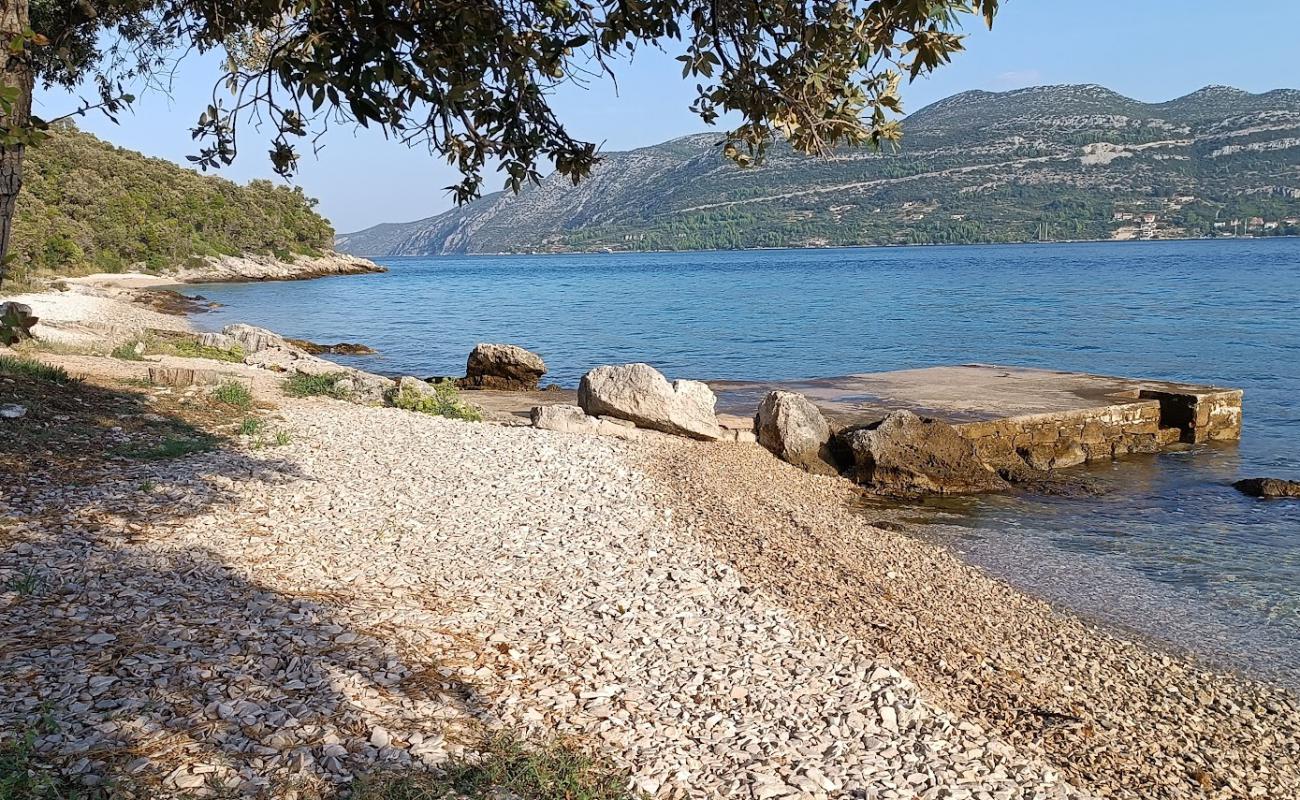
top-left (13, 126), bottom-right (334, 274)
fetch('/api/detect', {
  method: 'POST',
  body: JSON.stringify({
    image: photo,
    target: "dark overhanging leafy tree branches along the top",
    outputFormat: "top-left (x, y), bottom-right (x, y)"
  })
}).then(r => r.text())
top-left (15, 0), bottom-right (998, 200)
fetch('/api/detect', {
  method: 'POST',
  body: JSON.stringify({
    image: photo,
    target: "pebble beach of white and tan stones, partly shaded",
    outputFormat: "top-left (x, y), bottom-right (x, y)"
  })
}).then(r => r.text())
top-left (0, 284), bottom-right (1300, 800)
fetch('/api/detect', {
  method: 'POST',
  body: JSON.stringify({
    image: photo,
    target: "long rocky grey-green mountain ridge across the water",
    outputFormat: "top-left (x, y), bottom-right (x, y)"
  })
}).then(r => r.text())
top-left (337, 86), bottom-right (1300, 256)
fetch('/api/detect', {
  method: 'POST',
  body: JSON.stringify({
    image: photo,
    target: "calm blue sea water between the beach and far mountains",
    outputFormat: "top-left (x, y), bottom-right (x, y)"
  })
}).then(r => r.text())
top-left (192, 239), bottom-right (1300, 687)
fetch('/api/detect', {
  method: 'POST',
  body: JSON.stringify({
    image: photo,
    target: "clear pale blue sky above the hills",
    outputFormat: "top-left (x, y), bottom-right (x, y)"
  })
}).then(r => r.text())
top-left (36, 0), bottom-right (1300, 232)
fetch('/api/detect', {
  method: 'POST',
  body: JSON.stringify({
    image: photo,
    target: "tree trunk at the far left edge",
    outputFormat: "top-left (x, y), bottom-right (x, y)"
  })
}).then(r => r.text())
top-left (0, 0), bottom-right (35, 286)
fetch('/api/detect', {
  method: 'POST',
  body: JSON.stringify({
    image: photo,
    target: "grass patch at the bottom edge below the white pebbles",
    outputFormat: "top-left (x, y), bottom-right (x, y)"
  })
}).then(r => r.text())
top-left (350, 736), bottom-right (637, 800)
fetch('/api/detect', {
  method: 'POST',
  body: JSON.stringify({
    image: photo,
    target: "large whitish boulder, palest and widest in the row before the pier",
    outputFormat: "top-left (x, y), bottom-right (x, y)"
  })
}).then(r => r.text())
top-left (577, 364), bottom-right (722, 441)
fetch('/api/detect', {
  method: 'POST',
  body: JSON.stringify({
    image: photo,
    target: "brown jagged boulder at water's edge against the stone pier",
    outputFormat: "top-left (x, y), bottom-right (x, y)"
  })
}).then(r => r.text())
top-left (840, 411), bottom-right (1008, 497)
